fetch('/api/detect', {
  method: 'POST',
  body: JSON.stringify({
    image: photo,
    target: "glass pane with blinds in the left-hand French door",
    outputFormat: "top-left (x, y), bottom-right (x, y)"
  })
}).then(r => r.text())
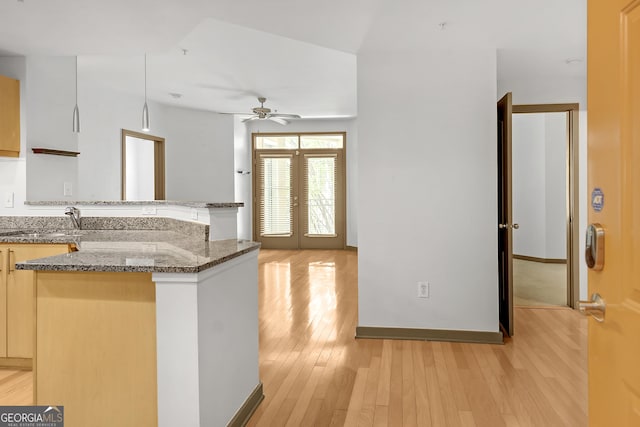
top-left (260, 157), bottom-right (293, 236)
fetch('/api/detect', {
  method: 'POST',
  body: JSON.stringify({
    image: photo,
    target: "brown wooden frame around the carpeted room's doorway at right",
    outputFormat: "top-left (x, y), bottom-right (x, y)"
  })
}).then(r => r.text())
top-left (512, 103), bottom-right (580, 308)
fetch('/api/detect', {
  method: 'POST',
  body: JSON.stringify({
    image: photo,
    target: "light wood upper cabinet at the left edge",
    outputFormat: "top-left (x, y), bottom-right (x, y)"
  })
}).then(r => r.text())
top-left (0, 76), bottom-right (20, 157)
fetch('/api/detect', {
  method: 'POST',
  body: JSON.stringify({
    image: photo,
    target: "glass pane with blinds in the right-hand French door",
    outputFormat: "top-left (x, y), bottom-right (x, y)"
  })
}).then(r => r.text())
top-left (305, 156), bottom-right (336, 235)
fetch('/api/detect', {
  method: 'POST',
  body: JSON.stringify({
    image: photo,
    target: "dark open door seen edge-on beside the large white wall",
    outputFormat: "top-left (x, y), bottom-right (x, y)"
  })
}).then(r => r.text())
top-left (498, 92), bottom-right (513, 336)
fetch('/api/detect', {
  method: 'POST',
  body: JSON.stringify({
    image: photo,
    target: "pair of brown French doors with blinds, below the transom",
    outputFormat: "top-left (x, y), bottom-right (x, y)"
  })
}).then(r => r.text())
top-left (254, 134), bottom-right (346, 249)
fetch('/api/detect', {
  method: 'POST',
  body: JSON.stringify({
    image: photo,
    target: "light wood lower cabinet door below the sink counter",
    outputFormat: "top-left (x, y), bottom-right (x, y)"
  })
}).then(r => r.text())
top-left (5, 244), bottom-right (69, 358)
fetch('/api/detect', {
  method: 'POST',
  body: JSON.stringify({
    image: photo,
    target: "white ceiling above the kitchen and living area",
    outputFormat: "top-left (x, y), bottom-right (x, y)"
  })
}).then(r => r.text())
top-left (0, 0), bottom-right (586, 117)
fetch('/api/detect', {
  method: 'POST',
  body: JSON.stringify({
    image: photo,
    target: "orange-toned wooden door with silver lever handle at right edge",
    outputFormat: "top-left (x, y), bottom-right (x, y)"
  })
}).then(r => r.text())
top-left (587, 0), bottom-right (640, 427)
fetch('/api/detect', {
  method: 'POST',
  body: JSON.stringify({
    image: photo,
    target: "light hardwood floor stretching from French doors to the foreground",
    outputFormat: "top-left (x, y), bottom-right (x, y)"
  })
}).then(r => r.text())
top-left (249, 250), bottom-right (588, 427)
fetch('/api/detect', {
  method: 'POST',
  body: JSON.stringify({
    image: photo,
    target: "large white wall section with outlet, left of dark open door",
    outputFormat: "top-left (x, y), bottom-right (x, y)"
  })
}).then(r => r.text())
top-left (358, 49), bottom-right (498, 332)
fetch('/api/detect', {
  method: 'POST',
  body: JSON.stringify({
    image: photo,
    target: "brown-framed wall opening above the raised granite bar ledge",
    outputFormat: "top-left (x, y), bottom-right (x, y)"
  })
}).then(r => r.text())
top-left (121, 129), bottom-right (165, 200)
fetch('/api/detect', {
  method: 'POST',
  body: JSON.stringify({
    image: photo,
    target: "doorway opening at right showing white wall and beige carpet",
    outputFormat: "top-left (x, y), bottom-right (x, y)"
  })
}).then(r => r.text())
top-left (512, 106), bottom-right (570, 306)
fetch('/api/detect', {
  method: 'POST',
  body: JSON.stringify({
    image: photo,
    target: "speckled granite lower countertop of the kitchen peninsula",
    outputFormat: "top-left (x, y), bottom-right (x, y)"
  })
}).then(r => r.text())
top-left (0, 230), bottom-right (260, 273)
